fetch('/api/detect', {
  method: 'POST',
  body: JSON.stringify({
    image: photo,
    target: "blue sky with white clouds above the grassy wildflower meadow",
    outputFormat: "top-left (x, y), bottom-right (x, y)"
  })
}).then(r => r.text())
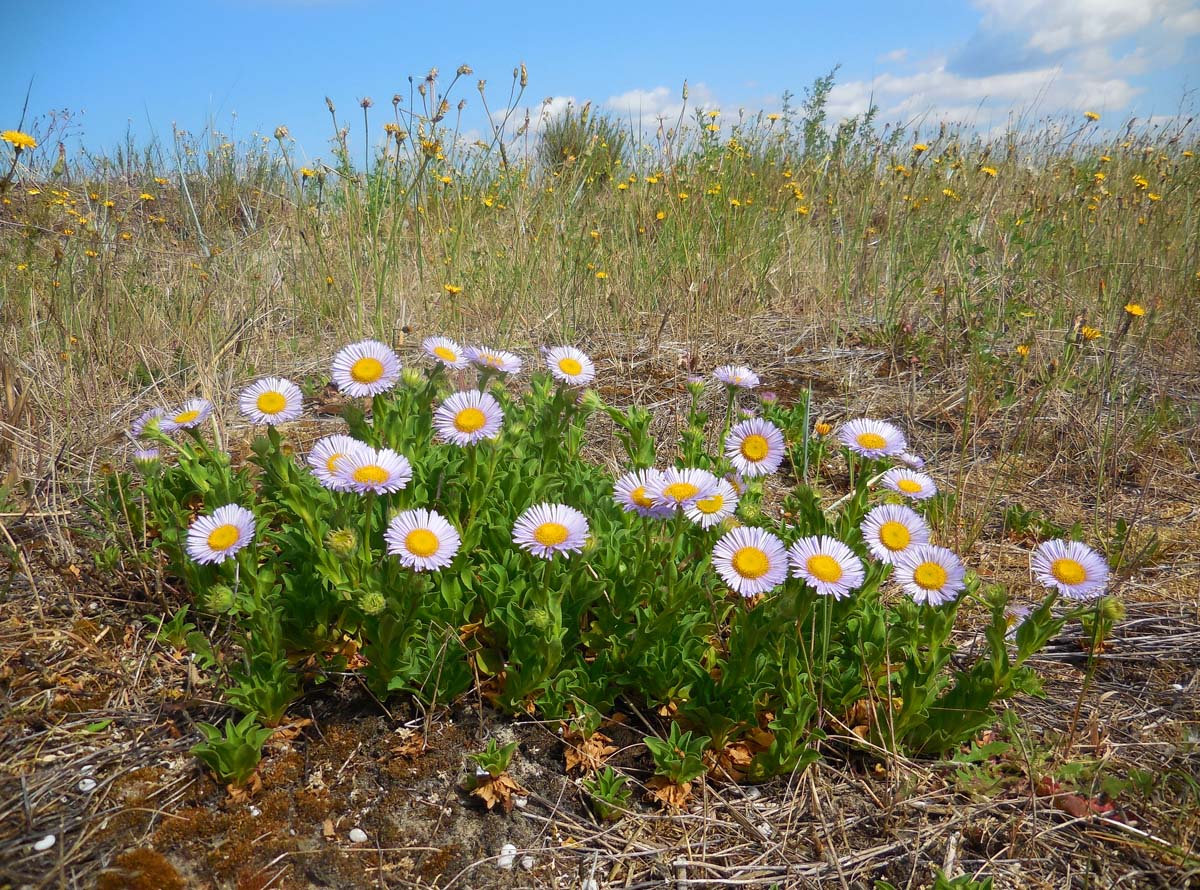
top-left (0, 0), bottom-right (1200, 157)
